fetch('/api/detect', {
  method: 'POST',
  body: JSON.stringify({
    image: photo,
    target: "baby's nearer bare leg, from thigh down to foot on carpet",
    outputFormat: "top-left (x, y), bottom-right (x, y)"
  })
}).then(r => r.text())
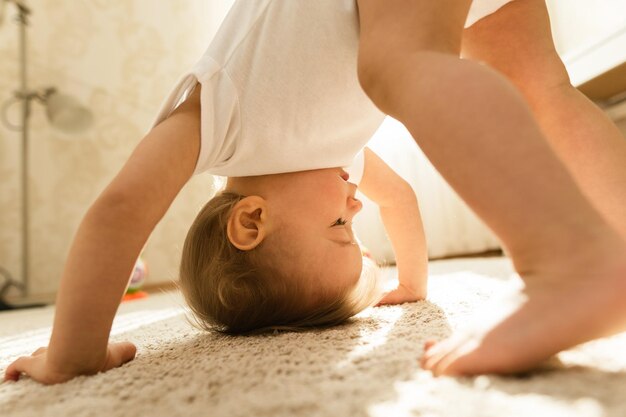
top-left (359, 0), bottom-right (626, 374)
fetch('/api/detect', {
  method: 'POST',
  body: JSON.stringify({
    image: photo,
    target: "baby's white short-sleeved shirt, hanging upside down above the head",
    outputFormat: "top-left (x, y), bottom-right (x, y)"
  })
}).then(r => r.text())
top-left (156, 0), bottom-right (384, 176)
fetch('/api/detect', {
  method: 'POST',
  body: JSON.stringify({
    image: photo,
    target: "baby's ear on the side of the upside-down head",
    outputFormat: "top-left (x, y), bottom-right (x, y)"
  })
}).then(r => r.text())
top-left (226, 196), bottom-right (267, 251)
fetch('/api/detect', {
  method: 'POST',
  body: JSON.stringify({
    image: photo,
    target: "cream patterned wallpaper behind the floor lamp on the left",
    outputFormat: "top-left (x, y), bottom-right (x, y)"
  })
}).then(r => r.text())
top-left (0, 0), bottom-right (232, 295)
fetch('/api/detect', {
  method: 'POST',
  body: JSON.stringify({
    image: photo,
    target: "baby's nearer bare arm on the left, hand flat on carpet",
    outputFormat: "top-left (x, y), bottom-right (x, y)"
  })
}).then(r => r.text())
top-left (5, 85), bottom-right (200, 384)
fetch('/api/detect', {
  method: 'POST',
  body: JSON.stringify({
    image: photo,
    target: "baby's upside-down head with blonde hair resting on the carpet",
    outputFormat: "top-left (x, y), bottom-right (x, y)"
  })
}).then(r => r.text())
top-left (180, 168), bottom-right (380, 333)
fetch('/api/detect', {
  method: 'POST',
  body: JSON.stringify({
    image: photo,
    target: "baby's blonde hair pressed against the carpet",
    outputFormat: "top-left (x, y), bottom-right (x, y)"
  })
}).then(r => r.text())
top-left (179, 191), bottom-right (382, 334)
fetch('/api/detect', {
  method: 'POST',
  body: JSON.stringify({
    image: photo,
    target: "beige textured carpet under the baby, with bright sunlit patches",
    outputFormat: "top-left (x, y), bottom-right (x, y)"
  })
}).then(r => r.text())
top-left (0, 258), bottom-right (626, 417)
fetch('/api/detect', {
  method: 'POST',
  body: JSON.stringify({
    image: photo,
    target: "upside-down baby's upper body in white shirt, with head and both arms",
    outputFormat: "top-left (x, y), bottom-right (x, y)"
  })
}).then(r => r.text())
top-left (5, 0), bottom-right (427, 384)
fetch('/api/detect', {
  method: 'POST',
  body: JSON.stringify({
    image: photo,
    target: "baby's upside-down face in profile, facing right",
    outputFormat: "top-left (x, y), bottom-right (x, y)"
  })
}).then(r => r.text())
top-left (268, 168), bottom-right (363, 291)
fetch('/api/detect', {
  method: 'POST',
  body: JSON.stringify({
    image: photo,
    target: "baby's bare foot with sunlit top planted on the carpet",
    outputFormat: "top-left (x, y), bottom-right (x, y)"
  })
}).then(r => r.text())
top-left (421, 248), bottom-right (626, 375)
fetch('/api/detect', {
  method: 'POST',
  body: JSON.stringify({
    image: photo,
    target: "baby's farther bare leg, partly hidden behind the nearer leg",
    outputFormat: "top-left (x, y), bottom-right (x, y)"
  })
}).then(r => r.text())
top-left (463, 0), bottom-right (626, 237)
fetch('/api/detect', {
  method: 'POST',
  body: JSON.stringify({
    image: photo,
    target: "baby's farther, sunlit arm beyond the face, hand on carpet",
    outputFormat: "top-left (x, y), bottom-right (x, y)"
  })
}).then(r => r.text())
top-left (359, 148), bottom-right (428, 304)
